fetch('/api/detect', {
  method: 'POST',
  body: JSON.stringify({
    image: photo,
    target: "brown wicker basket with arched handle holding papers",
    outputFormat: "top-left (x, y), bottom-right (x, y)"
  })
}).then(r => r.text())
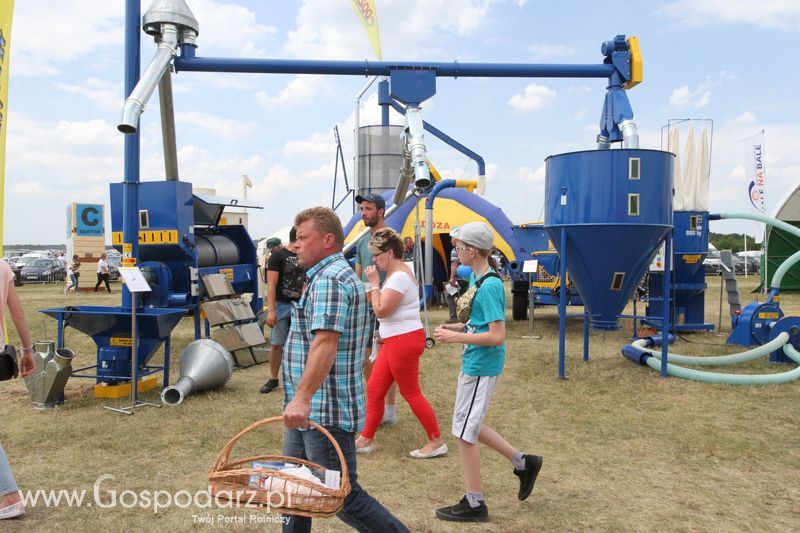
top-left (208, 416), bottom-right (350, 518)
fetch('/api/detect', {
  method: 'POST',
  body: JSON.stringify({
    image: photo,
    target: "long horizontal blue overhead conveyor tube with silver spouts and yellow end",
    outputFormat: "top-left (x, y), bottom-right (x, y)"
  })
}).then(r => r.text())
top-left (118, 0), bottom-right (641, 304)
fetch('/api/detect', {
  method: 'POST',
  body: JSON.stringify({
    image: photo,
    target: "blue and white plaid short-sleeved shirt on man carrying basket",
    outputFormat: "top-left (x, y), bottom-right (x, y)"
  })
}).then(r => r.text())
top-left (283, 253), bottom-right (369, 433)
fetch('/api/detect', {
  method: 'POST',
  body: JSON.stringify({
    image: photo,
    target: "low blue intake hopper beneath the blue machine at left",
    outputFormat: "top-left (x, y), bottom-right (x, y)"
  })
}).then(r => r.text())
top-left (40, 305), bottom-right (186, 366)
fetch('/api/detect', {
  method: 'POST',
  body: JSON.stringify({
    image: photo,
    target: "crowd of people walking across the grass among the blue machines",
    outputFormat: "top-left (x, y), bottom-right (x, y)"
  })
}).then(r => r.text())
top-left (0, 200), bottom-right (542, 531)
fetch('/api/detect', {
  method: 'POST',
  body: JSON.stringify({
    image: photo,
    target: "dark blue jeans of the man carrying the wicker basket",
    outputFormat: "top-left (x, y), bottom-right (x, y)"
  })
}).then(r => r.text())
top-left (283, 426), bottom-right (408, 533)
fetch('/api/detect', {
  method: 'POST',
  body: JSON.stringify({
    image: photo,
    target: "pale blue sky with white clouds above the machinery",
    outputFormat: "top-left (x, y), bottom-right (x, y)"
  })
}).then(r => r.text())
top-left (4, 0), bottom-right (800, 244)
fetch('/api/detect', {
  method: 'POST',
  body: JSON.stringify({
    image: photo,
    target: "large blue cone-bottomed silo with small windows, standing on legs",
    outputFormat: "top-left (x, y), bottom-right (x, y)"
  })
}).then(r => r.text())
top-left (545, 149), bottom-right (675, 329)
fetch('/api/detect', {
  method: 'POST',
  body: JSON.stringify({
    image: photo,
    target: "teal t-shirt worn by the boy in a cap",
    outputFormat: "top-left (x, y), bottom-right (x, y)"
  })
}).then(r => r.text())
top-left (461, 274), bottom-right (506, 376)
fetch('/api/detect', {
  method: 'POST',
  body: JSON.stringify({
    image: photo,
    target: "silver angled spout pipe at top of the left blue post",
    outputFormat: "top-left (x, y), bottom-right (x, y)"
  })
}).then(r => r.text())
top-left (117, 23), bottom-right (178, 135)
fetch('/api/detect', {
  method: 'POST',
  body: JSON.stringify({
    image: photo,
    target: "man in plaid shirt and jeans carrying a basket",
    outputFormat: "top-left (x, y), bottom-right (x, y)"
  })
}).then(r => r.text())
top-left (283, 207), bottom-right (408, 531)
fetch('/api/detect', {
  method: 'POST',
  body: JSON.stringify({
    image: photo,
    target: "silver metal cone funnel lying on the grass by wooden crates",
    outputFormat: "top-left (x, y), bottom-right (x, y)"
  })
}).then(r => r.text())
top-left (161, 339), bottom-right (233, 405)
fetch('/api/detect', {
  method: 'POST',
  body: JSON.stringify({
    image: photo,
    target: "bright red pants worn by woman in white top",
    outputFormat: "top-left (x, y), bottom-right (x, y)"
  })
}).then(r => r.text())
top-left (361, 329), bottom-right (441, 439)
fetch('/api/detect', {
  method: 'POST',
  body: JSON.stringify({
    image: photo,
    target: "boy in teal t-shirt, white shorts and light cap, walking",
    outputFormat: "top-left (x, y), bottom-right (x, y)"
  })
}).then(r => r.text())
top-left (433, 222), bottom-right (542, 522)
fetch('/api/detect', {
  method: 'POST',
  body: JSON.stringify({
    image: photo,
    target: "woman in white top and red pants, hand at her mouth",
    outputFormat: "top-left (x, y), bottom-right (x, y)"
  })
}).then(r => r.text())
top-left (356, 228), bottom-right (447, 459)
